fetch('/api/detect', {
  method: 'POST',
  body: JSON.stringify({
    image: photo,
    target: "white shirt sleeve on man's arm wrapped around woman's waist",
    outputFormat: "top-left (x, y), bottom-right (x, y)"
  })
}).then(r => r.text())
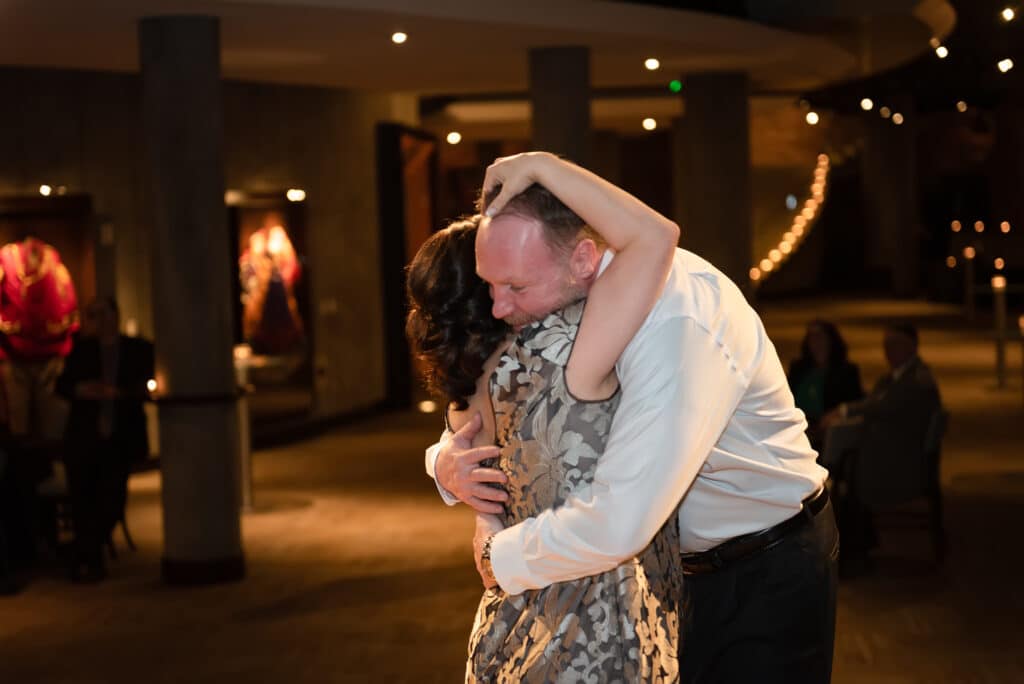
top-left (490, 317), bottom-right (749, 594)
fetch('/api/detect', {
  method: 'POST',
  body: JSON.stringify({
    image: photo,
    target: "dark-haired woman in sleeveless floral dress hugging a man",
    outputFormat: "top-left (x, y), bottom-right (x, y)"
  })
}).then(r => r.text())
top-left (408, 155), bottom-right (681, 682)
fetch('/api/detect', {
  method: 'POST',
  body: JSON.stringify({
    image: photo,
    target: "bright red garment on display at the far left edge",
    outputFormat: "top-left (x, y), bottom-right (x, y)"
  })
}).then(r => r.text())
top-left (0, 238), bottom-right (79, 360)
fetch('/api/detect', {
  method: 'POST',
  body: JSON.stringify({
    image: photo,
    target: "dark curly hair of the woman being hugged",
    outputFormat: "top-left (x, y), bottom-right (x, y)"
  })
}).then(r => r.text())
top-left (406, 215), bottom-right (509, 410)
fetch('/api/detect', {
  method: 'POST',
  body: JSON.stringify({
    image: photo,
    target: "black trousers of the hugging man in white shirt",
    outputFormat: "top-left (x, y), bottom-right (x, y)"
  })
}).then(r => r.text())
top-left (680, 503), bottom-right (839, 684)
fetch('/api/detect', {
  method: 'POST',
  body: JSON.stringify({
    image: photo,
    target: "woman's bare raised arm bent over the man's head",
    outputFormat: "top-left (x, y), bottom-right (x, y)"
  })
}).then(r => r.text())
top-left (483, 153), bottom-right (679, 398)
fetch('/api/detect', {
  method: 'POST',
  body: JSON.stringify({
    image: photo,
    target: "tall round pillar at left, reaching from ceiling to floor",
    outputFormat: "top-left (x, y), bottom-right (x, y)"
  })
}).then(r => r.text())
top-left (139, 16), bottom-right (245, 584)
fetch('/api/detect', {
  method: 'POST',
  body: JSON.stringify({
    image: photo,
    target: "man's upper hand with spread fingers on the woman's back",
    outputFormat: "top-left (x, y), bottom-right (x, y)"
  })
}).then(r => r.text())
top-left (434, 413), bottom-right (509, 514)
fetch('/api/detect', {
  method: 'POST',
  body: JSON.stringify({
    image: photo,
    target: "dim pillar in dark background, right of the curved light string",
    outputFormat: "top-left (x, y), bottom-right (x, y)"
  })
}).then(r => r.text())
top-left (861, 96), bottom-right (922, 297)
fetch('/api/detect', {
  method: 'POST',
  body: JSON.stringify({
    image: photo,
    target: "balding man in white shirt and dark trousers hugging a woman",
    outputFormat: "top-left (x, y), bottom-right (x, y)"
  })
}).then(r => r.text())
top-left (427, 150), bottom-right (838, 682)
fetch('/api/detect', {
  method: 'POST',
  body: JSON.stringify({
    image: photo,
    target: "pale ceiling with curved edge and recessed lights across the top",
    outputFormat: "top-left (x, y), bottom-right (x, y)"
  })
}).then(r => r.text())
top-left (0, 0), bottom-right (944, 94)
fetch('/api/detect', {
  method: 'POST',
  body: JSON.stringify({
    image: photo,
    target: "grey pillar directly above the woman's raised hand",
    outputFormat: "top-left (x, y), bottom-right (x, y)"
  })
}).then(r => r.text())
top-left (529, 47), bottom-right (590, 166)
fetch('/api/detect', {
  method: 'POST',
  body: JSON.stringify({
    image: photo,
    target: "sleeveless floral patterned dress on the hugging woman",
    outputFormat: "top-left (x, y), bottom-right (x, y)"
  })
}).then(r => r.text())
top-left (466, 301), bottom-right (682, 683)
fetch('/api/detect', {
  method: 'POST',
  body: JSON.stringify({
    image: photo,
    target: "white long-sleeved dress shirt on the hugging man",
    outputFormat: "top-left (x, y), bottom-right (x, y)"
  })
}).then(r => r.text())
top-left (426, 249), bottom-right (826, 594)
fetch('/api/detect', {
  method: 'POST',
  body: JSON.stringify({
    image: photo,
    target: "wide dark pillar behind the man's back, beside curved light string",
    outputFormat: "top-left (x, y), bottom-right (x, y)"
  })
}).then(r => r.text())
top-left (673, 73), bottom-right (754, 292)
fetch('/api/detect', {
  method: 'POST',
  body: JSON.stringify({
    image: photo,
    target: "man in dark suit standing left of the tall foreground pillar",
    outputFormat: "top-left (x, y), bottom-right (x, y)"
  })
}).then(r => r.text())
top-left (56, 298), bottom-right (154, 581)
